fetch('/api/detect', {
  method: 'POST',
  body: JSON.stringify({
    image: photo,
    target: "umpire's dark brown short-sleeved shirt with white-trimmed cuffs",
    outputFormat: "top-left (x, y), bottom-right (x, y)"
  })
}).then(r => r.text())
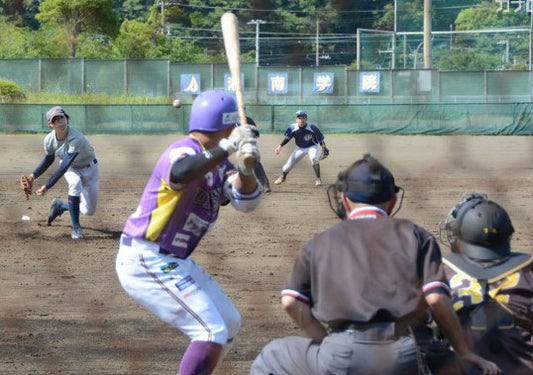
top-left (282, 206), bottom-right (449, 323)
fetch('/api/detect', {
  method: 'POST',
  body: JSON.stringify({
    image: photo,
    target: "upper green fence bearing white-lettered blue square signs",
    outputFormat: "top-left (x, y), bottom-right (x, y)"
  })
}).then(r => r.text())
top-left (0, 59), bottom-right (533, 105)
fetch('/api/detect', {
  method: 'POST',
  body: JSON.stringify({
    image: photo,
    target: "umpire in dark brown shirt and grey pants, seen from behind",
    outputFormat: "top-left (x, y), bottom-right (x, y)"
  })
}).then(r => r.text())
top-left (250, 154), bottom-right (499, 375)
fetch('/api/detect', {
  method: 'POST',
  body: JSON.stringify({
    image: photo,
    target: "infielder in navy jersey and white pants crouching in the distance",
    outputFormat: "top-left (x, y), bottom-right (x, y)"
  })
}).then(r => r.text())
top-left (274, 111), bottom-right (329, 186)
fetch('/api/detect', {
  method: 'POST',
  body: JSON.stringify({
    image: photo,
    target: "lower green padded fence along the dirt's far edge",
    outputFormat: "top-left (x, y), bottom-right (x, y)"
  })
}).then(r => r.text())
top-left (0, 103), bottom-right (533, 135)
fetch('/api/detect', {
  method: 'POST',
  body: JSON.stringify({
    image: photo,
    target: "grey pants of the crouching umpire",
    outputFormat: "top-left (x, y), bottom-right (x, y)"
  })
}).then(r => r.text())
top-left (250, 331), bottom-right (419, 375)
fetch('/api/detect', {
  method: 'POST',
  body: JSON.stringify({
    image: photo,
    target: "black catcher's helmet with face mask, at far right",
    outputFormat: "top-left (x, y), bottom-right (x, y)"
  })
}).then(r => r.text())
top-left (439, 193), bottom-right (514, 260)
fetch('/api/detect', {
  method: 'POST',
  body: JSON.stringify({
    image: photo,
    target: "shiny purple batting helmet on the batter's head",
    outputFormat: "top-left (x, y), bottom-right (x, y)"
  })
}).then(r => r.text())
top-left (189, 90), bottom-right (239, 132)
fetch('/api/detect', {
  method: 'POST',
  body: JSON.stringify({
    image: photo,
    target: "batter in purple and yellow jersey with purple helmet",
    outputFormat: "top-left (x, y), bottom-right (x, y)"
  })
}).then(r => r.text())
top-left (116, 90), bottom-right (261, 375)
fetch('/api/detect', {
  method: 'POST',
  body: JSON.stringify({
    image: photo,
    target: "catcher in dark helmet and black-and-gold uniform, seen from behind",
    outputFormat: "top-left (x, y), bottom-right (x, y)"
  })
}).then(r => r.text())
top-left (442, 193), bottom-right (533, 375)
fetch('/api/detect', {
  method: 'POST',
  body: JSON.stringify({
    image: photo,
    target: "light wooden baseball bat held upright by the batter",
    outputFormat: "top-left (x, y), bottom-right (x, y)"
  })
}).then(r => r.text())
top-left (220, 12), bottom-right (247, 125)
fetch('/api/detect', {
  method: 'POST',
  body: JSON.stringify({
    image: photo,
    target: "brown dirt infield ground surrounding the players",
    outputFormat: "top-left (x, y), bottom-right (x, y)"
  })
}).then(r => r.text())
top-left (0, 135), bottom-right (533, 375)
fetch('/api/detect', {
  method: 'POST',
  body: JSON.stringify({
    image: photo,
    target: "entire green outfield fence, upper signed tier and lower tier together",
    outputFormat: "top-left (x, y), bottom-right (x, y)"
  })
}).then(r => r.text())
top-left (0, 59), bottom-right (533, 134)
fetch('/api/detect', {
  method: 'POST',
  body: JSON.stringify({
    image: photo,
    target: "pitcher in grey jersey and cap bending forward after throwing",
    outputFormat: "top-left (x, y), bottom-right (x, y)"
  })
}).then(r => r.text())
top-left (20, 107), bottom-right (99, 239)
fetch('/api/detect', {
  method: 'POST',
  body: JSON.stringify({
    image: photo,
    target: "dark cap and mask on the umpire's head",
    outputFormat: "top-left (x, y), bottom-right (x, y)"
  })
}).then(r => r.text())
top-left (327, 154), bottom-right (403, 220)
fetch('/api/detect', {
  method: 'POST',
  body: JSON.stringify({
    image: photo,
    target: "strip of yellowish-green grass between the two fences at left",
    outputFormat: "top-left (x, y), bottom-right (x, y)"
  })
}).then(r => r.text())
top-left (24, 92), bottom-right (172, 104)
